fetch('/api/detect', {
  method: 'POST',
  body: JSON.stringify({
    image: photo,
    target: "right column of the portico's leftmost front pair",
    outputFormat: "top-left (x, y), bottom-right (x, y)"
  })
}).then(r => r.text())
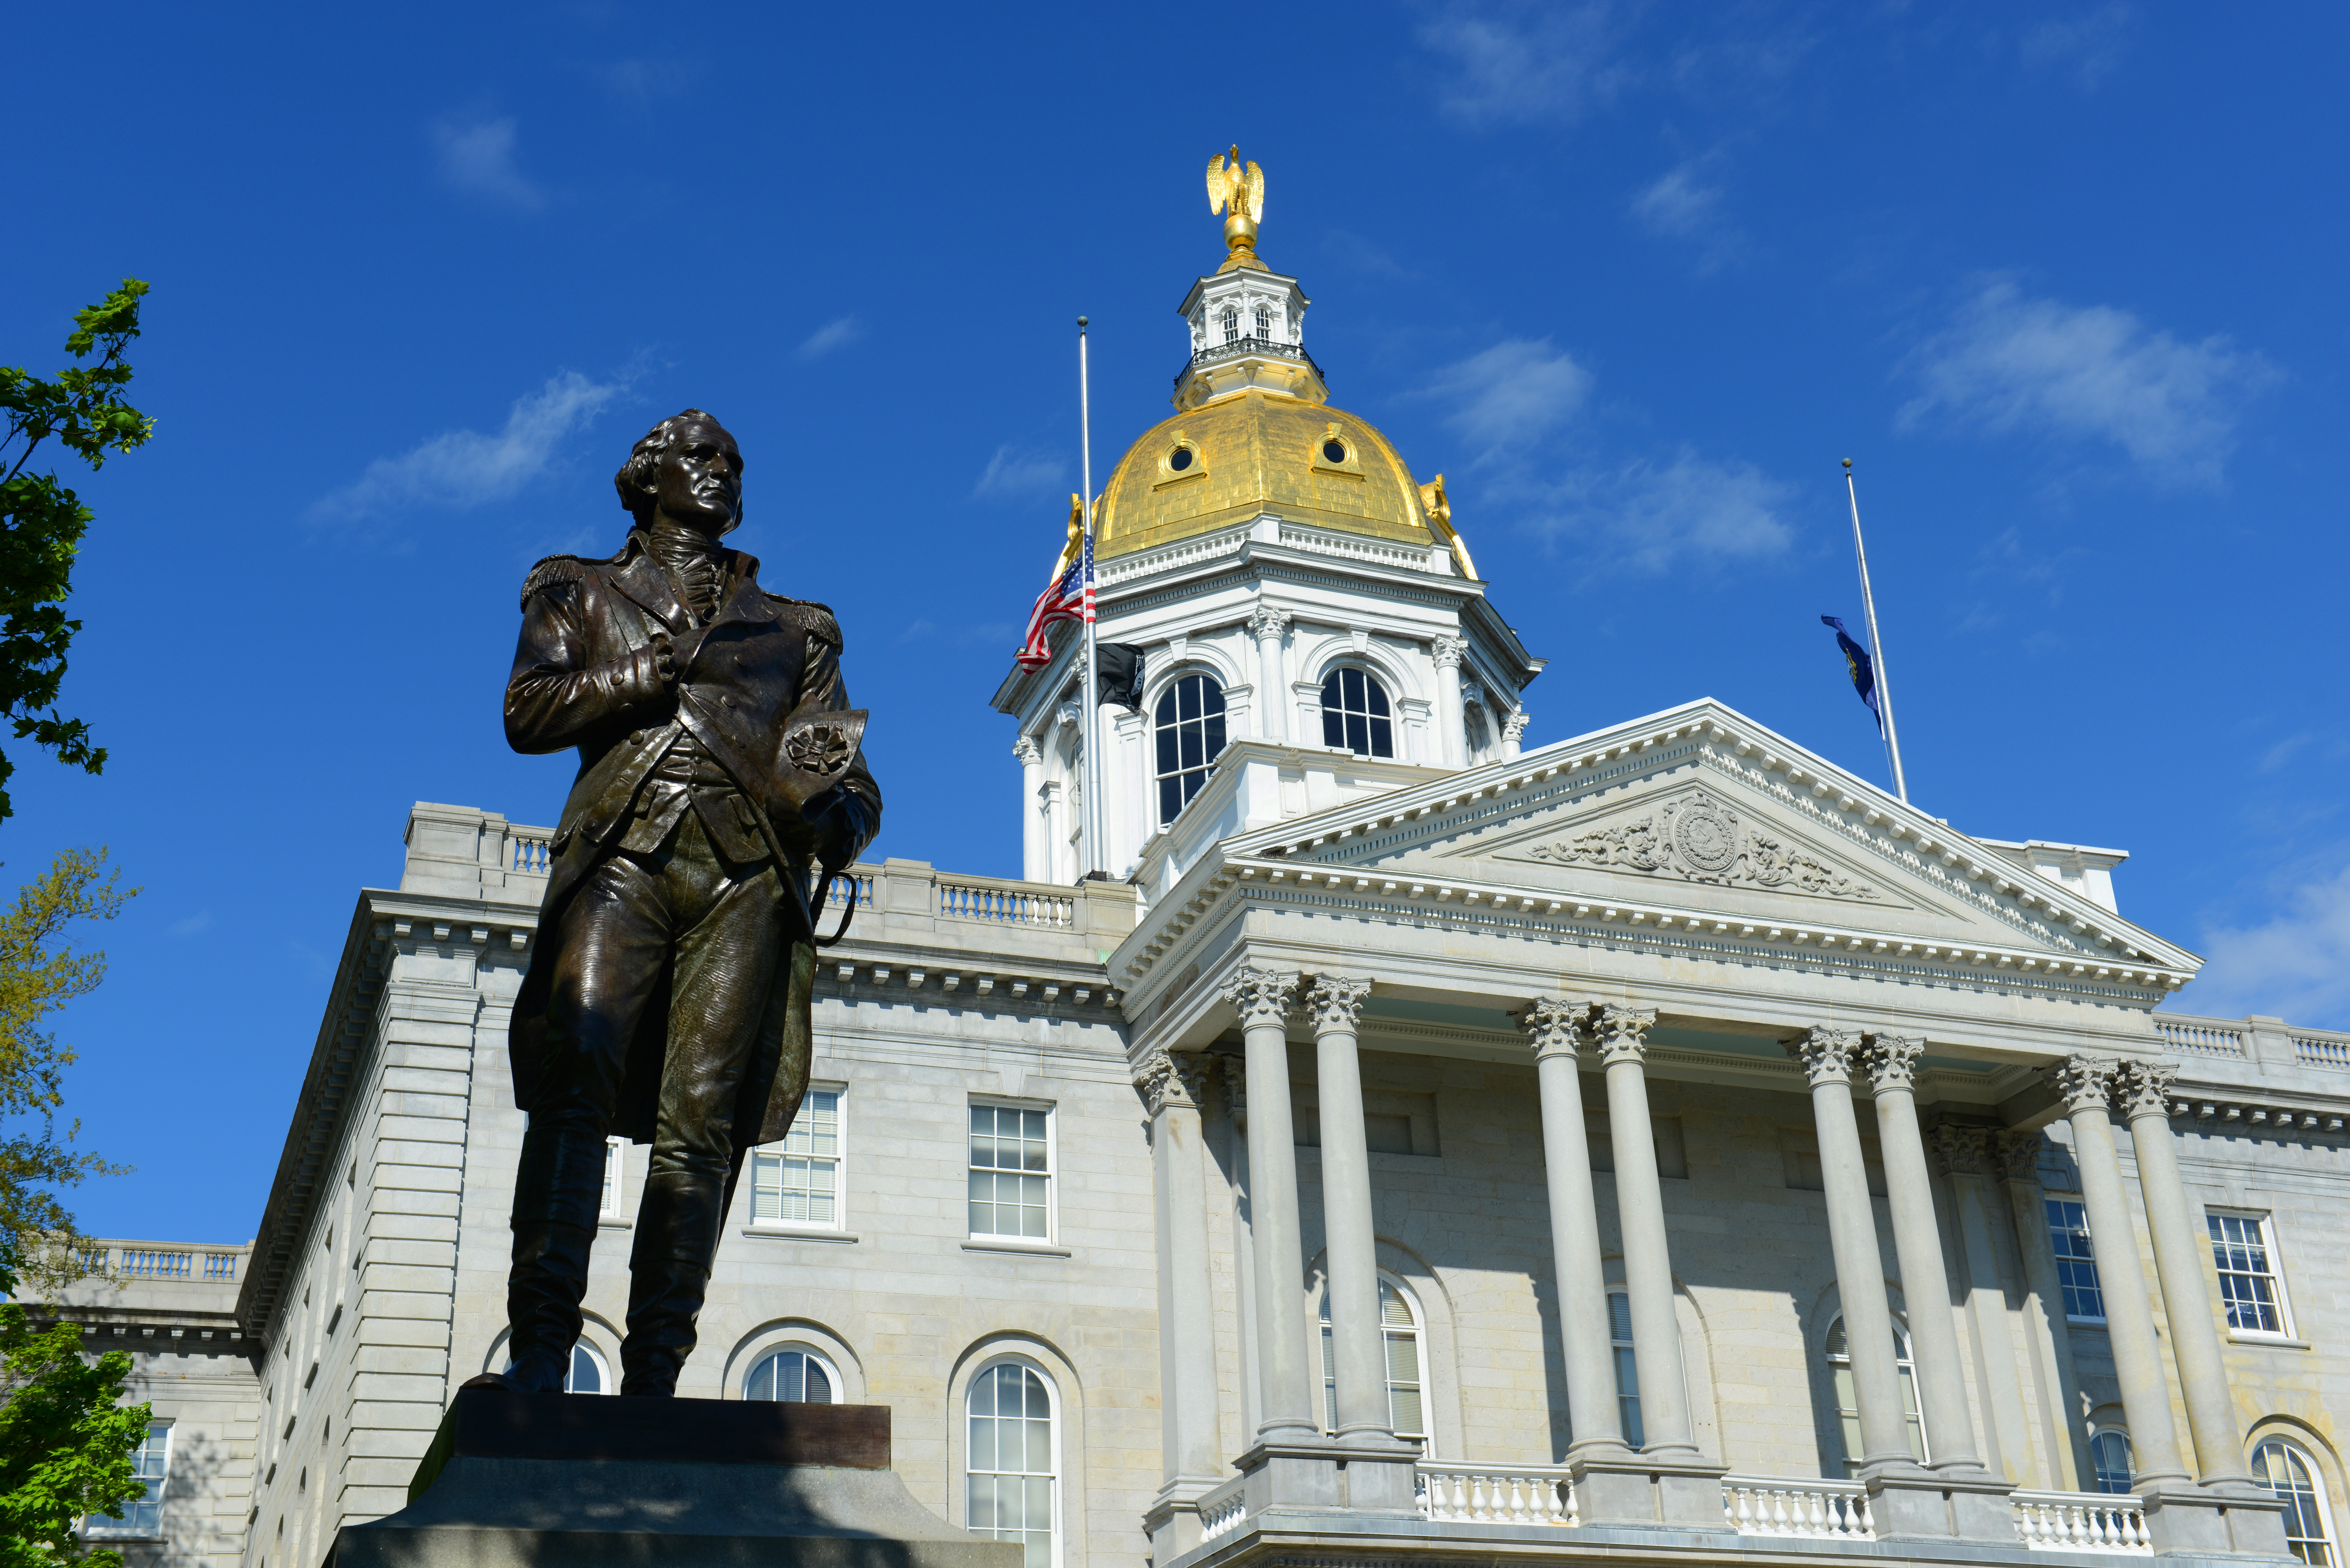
top-left (1307, 976), bottom-right (1393, 1446)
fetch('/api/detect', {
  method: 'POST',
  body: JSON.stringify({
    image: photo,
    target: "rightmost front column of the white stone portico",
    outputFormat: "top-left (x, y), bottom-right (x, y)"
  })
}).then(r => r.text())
top-left (2124, 1063), bottom-right (2251, 1486)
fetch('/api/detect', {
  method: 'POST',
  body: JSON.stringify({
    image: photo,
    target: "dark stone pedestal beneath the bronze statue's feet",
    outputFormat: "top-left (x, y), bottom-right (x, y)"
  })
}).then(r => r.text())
top-left (327, 1387), bottom-right (1020, 1568)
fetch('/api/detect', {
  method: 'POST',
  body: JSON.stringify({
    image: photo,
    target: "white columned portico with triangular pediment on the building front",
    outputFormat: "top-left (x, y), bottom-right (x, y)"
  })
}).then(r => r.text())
top-left (1109, 703), bottom-right (2279, 1563)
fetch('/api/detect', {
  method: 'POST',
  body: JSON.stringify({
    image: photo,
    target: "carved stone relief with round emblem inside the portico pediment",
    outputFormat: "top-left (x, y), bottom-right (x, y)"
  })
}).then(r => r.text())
top-left (1506, 790), bottom-right (1885, 903)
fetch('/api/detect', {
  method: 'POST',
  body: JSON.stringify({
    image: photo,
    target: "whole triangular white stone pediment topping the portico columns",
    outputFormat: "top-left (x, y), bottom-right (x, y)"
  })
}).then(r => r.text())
top-left (1194, 701), bottom-right (2200, 994)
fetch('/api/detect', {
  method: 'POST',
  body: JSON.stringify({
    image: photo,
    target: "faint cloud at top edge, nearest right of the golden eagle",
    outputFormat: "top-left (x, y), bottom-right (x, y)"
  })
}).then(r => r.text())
top-left (1419, 0), bottom-right (1631, 127)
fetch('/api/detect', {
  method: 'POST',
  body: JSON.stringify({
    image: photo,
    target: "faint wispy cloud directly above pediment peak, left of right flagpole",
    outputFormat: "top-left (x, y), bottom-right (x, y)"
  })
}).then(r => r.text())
top-left (1528, 447), bottom-right (1795, 571)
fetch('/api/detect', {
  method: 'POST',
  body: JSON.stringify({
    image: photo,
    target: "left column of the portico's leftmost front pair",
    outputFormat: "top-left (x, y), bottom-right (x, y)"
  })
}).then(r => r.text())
top-left (1224, 969), bottom-right (1321, 1441)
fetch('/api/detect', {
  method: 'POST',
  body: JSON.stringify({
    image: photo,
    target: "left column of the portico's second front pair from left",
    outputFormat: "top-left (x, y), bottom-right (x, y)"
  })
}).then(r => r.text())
top-left (1518, 997), bottom-right (1638, 1458)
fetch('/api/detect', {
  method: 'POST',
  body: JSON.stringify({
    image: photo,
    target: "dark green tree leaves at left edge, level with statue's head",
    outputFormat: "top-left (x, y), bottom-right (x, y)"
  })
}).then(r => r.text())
top-left (0, 277), bottom-right (155, 818)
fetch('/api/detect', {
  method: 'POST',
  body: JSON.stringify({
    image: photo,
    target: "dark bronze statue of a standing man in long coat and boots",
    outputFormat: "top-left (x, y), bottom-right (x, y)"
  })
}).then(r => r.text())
top-left (505, 409), bottom-right (881, 1394)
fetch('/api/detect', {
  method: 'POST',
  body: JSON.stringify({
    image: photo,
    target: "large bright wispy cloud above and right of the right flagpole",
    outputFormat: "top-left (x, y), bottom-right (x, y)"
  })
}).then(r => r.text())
top-left (1899, 277), bottom-right (2277, 489)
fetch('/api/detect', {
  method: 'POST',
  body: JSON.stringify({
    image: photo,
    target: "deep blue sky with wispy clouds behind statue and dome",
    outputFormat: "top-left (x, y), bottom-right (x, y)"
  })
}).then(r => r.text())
top-left (0, 2), bottom-right (2350, 1239)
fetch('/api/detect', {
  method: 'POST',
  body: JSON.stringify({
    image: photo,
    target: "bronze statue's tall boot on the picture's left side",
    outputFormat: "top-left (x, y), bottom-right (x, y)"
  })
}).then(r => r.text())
top-left (505, 1117), bottom-right (606, 1394)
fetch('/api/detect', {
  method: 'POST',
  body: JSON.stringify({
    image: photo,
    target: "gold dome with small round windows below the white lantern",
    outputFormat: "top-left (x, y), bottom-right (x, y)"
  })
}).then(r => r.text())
top-left (1093, 388), bottom-right (1448, 560)
